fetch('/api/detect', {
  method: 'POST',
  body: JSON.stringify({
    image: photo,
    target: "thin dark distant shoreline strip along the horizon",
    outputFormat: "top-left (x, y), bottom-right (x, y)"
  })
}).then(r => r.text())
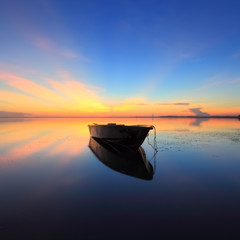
top-left (0, 116), bottom-right (240, 119)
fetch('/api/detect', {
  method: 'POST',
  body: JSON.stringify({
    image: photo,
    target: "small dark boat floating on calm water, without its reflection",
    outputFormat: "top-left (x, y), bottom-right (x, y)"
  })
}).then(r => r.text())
top-left (88, 123), bottom-right (154, 148)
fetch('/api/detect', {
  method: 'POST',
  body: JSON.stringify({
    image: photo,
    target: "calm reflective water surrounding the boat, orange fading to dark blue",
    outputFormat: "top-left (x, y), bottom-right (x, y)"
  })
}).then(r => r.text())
top-left (0, 119), bottom-right (240, 239)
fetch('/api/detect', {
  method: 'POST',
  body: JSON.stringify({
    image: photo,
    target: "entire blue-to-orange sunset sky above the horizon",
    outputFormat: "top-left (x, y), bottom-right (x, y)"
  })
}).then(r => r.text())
top-left (0, 0), bottom-right (240, 117)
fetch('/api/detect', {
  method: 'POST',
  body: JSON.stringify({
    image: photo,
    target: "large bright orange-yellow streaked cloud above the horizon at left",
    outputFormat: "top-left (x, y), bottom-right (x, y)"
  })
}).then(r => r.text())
top-left (0, 73), bottom-right (109, 116)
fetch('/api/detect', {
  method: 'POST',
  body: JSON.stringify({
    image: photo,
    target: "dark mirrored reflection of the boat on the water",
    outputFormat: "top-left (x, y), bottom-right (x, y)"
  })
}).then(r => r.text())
top-left (89, 137), bottom-right (154, 180)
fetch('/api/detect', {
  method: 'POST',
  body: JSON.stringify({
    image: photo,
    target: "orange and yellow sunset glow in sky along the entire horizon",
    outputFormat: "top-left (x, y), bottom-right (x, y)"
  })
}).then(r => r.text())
top-left (0, 73), bottom-right (240, 117)
